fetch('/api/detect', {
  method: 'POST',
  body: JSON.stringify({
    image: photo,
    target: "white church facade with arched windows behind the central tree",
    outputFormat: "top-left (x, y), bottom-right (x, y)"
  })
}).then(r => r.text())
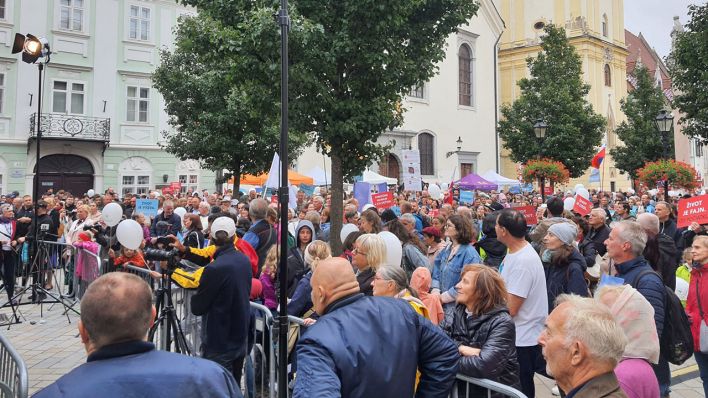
top-left (297, 0), bottom-right (504, 182)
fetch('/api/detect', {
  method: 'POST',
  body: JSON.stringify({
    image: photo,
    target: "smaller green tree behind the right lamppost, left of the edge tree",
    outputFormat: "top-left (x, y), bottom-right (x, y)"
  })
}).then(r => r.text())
top-left (610, 65), bottom-right (674, 180)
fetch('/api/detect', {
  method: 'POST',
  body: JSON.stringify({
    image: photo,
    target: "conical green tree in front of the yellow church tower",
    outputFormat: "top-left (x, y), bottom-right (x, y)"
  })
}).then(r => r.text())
top-left (498, 25), bottom-right (605, 177)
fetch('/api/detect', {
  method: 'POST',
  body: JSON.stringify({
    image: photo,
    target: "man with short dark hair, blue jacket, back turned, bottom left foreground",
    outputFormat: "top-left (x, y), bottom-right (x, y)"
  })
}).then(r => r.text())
top-left (34, 272), bottom-right (242, 398)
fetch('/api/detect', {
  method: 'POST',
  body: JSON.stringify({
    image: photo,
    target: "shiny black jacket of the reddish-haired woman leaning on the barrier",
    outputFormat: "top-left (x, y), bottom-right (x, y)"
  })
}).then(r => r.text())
top-left (441, 304), bottom-right (520, 396)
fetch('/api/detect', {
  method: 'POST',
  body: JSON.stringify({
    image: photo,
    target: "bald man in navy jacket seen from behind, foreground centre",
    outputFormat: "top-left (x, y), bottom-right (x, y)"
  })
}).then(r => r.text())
top-left (293, 258), bottom-right (459, 398)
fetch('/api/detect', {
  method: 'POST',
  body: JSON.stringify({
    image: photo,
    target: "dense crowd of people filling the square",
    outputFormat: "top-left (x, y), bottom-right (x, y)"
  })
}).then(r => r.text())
top-left (0, 184), bottom-right (708, 398)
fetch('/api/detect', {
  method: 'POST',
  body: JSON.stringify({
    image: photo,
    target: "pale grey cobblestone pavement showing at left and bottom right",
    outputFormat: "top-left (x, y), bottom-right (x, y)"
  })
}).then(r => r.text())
top-left (0, 296), bottom-right (703, 398)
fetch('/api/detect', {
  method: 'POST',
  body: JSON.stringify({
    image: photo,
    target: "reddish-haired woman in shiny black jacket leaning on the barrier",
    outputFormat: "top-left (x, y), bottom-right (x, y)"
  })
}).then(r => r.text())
top-left (441, 264), bottom-right (521, 397)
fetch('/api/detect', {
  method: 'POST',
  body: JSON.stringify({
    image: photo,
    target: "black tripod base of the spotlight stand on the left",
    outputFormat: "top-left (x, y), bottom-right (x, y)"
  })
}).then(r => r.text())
top-left (10, 239), bottom-right (80, 323)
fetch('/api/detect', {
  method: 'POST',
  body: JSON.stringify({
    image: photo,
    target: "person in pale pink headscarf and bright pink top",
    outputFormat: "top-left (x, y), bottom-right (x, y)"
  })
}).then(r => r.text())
top-left (595, 285), bottom-right (659, 398)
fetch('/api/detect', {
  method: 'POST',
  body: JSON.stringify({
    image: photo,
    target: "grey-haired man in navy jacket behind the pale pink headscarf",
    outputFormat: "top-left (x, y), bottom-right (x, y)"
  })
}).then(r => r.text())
top-left (605, 221), bottom-right (671, 397)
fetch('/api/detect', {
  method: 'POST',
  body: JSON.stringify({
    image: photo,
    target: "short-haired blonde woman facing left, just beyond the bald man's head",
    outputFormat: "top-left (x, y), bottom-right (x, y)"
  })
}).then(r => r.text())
top-left (352, 234), bottom-right (386, 296)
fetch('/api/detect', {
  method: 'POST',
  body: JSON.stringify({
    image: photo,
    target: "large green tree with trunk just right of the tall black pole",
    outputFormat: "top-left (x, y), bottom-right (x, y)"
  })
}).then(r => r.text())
top-left (177, 0), bottom-right (478, 253)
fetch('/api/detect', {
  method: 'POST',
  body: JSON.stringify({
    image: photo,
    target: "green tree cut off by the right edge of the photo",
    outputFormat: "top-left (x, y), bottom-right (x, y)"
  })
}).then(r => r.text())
top-left (668, 3), bottom-right (708, 144)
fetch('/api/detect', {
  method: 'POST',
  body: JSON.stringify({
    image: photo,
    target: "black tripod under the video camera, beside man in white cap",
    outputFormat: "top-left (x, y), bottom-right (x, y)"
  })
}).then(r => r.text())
top-left (148, 269), bottom-right (192, 355)
